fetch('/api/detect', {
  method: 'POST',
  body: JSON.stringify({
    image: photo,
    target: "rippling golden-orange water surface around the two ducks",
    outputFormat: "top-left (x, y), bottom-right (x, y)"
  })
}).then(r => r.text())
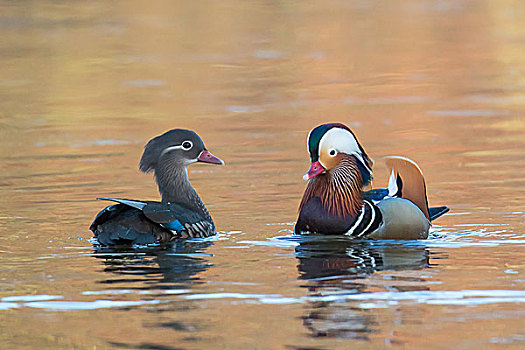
top-left (0, 0), bottom-right (525, 349)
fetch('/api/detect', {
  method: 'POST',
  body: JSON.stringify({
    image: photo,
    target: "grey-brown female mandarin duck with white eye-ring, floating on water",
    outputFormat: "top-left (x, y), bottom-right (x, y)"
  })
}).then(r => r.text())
top-left (90, 129), bottom-right (224, 245)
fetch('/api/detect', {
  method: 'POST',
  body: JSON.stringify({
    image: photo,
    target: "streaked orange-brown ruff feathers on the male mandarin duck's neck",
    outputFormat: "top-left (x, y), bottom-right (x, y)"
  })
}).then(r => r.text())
top-left (299, 153), bottom-right (363, 216)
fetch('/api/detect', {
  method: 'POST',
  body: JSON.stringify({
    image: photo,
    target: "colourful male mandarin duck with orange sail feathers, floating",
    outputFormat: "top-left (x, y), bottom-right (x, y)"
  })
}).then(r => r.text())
top-left (295, 123), bottom-right (448, 240)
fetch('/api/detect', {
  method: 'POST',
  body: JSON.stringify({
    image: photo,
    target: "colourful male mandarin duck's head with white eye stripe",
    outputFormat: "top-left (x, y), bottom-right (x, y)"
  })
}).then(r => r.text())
top-left (303, 123), bottom-right (374, 186)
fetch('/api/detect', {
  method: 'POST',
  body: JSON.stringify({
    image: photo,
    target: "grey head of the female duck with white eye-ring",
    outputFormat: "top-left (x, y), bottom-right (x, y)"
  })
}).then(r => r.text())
top-left (139, 129), bottom-right (224, 173)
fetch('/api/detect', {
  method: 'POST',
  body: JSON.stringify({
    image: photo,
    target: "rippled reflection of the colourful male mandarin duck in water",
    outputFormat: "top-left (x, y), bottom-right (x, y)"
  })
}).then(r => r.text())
top-left (295, 236), bottom-right (430, 340)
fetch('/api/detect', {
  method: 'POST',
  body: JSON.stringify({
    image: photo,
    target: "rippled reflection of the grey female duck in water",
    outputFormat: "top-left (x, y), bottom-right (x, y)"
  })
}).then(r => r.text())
top-left (93, 239), bottom-right (213, 349)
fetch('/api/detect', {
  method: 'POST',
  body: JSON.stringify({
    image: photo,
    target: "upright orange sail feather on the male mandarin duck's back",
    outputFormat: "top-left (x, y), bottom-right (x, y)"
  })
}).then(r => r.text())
top-left (385, 156), bottom-right (430, 220)
